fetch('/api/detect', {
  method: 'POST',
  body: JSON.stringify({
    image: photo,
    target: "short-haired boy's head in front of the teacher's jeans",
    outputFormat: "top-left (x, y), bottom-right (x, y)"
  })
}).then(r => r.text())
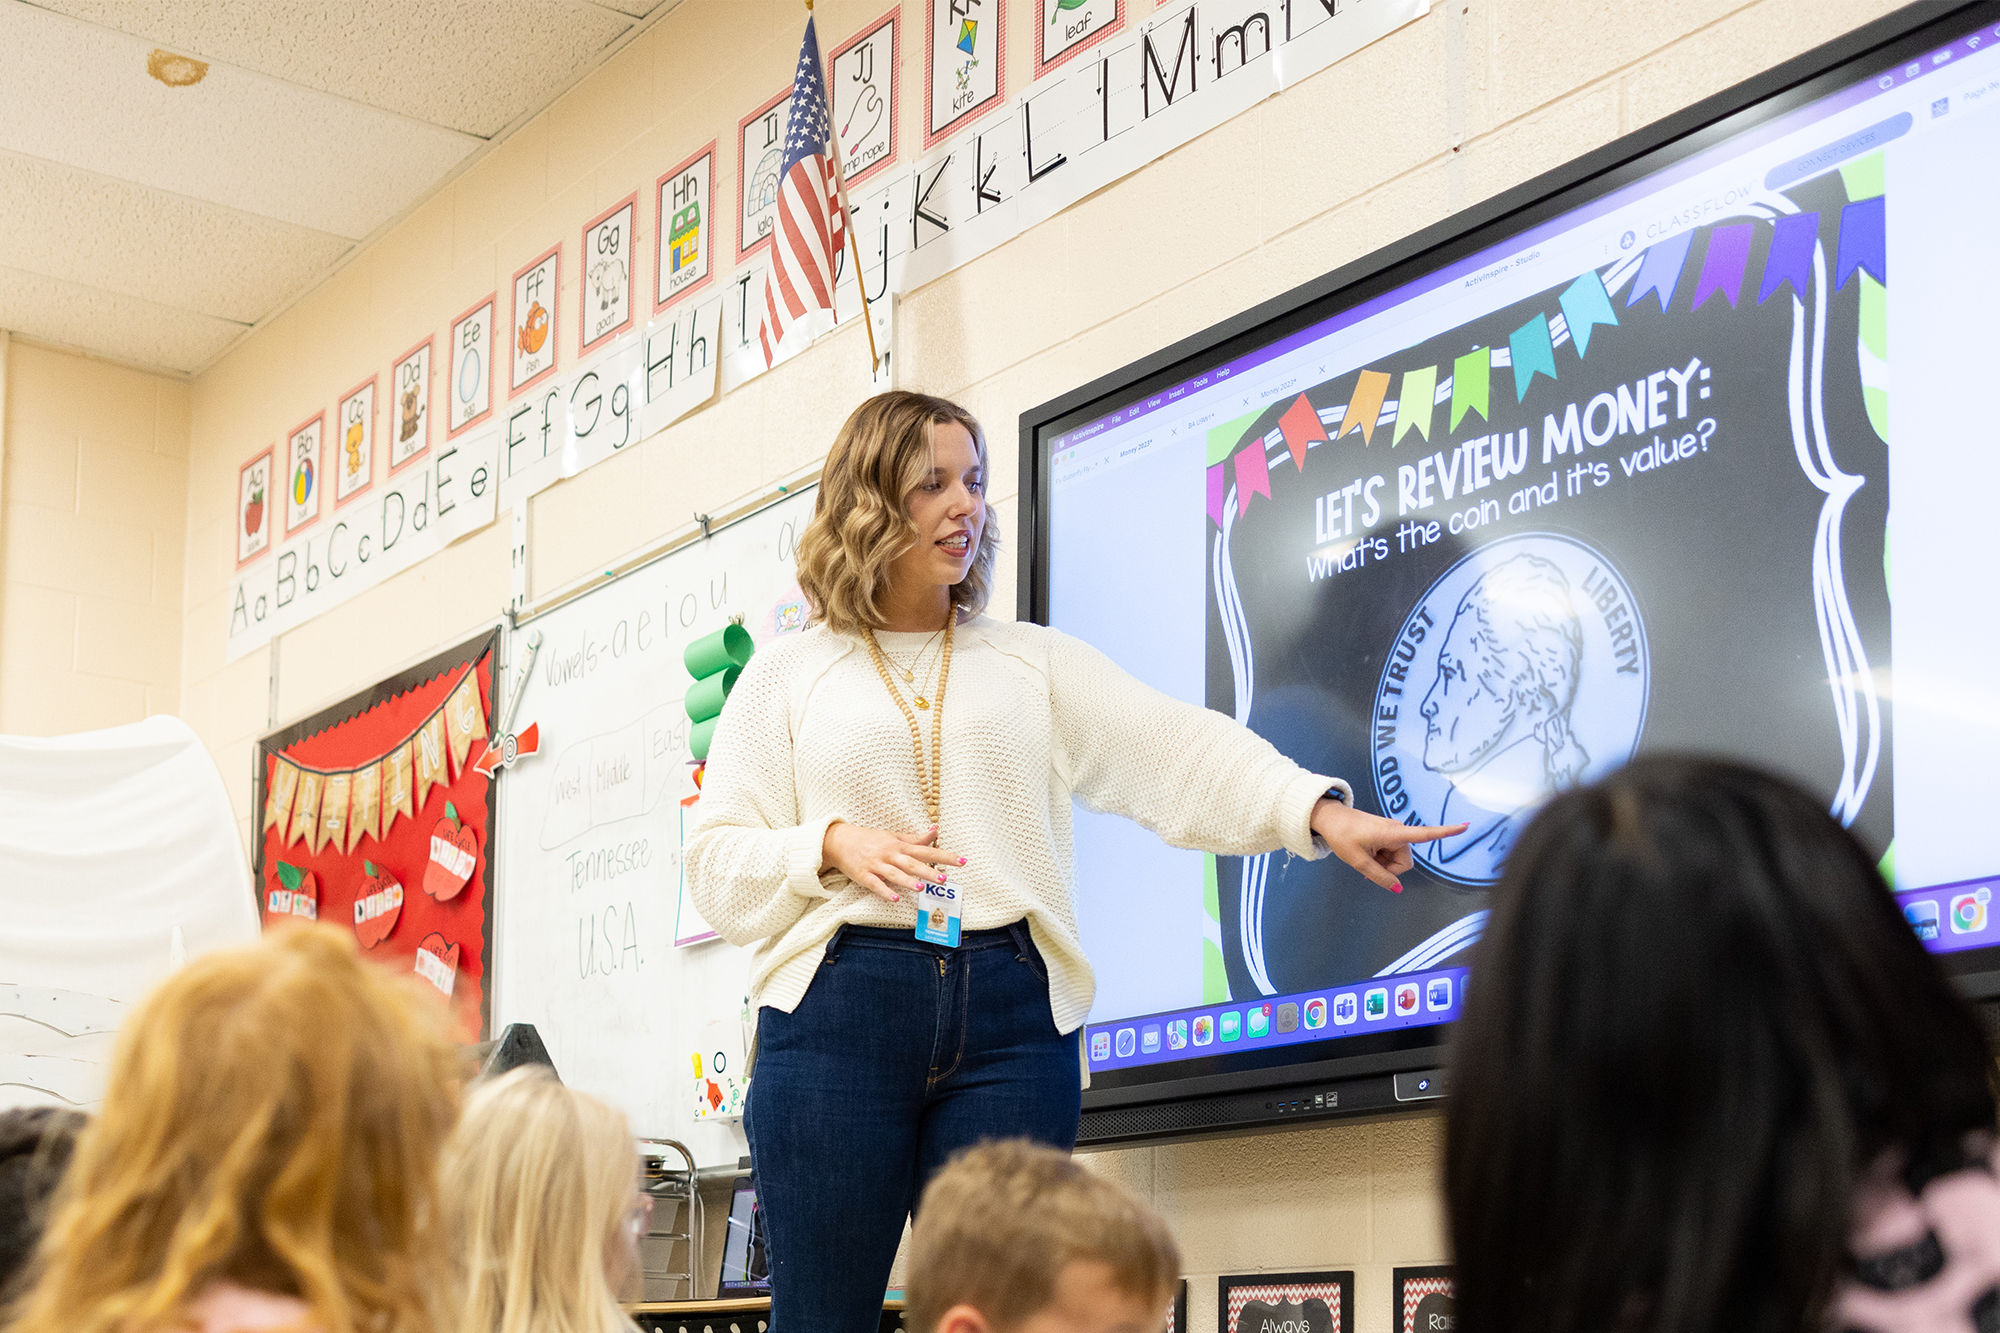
top-left (908, 1139), bottom-right (1180, 1333)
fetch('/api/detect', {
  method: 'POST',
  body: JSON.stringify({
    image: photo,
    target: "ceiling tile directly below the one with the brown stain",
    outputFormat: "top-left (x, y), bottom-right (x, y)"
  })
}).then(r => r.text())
top-left (0, 152), bottom-right (354, 324)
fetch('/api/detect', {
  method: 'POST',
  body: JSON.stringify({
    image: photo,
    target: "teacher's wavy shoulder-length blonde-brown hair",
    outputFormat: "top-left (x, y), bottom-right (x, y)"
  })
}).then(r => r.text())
top-left (798, 390), bottom-right (1000, 634)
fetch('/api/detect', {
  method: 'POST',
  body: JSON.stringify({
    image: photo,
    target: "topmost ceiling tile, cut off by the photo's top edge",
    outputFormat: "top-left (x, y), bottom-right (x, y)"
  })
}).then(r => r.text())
top-left (38, 0), bottom-right (640, 138)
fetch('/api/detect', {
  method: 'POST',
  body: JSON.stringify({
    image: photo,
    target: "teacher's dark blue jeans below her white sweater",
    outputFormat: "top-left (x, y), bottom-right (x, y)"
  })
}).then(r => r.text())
top-left (744, 923), bottom-right (1082, 1333)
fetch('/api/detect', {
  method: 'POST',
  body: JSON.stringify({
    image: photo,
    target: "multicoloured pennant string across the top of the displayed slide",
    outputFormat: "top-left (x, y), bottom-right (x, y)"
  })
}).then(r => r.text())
top-left (1208, 182), bottom-right (1888, 526)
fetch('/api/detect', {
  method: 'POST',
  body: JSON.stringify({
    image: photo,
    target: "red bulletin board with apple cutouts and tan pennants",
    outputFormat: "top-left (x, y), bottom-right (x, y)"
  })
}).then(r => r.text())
top-left (256, 630), bottom-right (500, 1041)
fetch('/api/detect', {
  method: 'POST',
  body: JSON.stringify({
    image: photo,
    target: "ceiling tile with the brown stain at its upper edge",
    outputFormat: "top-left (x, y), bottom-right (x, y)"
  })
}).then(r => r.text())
top-left (0, 2), bottom-right (480, 238)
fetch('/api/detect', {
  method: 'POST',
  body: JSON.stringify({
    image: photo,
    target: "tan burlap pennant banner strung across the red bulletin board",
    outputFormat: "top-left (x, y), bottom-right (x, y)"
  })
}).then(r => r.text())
top-left (264, 662), bottom-right (486, 855)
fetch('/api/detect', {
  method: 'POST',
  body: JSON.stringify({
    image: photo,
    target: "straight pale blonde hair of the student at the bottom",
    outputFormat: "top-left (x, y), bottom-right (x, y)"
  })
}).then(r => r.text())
top-left (444, 1067), bottom-right (638, 1333)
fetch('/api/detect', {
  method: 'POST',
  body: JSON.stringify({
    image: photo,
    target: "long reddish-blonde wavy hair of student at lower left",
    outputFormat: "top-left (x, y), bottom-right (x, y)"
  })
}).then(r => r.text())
top-left (8, 925), bottom-right (464, 1333)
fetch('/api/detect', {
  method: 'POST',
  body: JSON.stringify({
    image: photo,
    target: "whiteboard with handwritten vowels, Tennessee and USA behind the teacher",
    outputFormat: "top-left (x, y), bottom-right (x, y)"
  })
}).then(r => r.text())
top-left (494, 488), bottom-right (814, 1167)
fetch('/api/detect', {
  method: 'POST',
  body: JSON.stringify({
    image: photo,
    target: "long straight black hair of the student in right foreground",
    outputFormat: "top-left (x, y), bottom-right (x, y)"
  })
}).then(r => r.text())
top-left (1444, 757), bottom-right (1994, 1333)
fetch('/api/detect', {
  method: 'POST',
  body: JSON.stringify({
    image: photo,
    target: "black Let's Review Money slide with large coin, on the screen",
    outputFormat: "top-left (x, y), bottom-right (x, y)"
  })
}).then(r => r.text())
top-left (1206, 154), bottom-right (1890, 996)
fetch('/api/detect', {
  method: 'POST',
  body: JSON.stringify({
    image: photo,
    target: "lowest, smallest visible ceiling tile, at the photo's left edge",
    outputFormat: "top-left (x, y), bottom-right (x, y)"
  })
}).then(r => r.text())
top-left (0, 268), bottom-right (244, 374)
